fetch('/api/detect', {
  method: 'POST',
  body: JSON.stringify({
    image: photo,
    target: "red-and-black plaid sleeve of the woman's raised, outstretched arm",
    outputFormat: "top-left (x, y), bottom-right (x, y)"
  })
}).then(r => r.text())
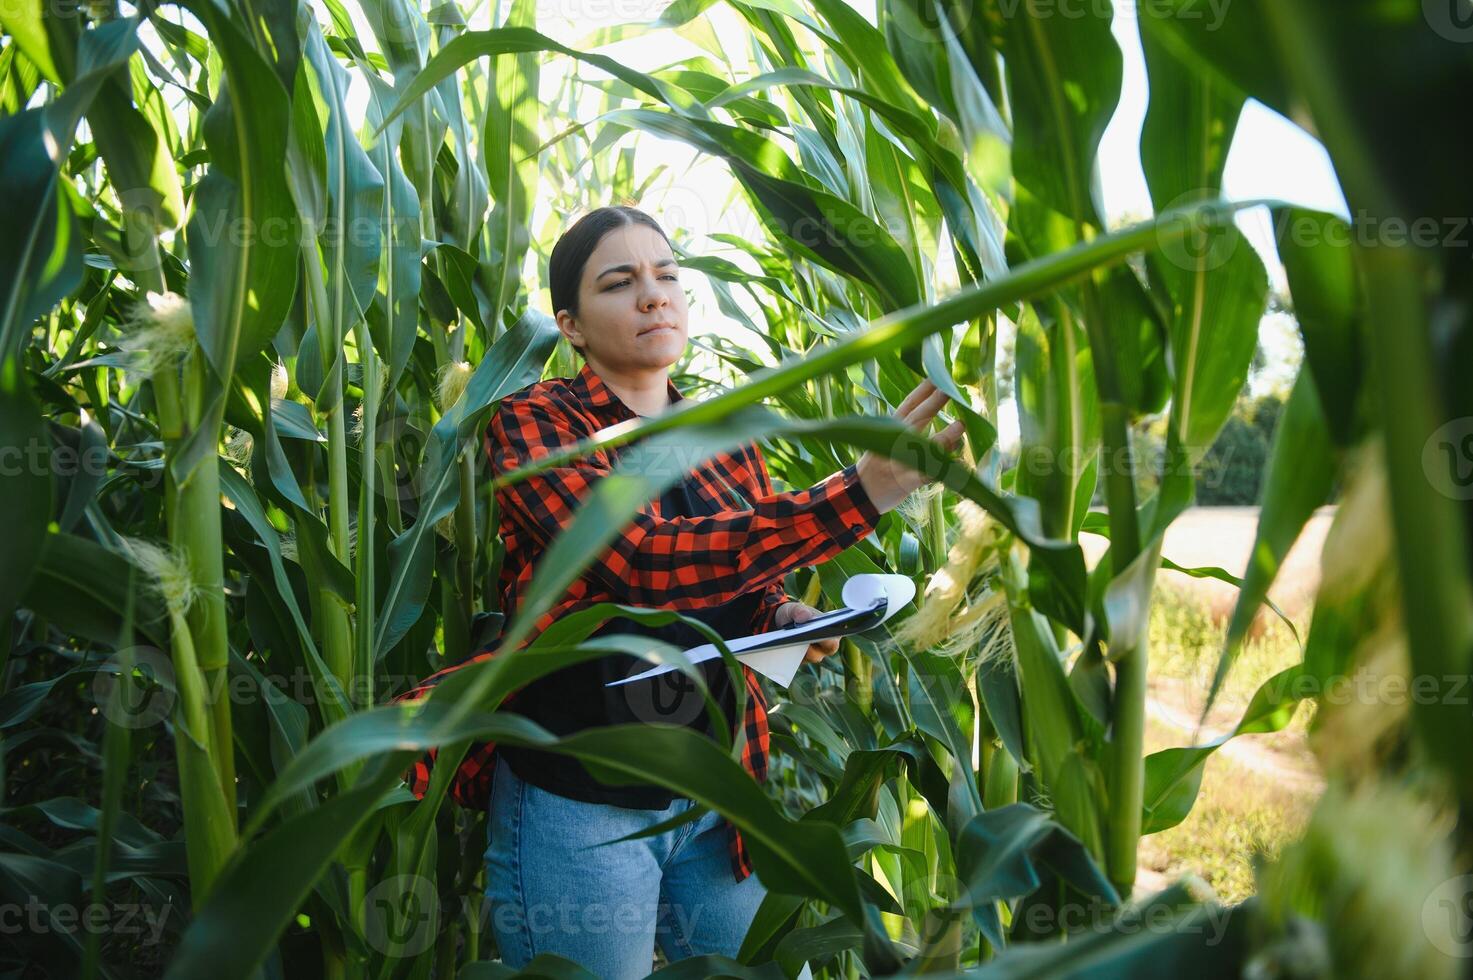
top-left (488, 396), bottom-right (881, 609)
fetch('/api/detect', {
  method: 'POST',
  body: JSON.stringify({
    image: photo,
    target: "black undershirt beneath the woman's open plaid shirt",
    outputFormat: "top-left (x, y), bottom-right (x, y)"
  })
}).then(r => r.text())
top-left (496, 477), bottom-right (762, 809)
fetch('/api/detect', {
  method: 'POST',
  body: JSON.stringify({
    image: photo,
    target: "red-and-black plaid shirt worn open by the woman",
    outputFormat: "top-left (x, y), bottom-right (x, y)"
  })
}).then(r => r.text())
top-left (395, 363), bottom-right (879, 881)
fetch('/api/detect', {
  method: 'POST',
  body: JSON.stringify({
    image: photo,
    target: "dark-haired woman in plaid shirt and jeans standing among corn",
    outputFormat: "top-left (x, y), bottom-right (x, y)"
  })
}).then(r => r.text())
top-left (409, 208), bottom-right (962, 977)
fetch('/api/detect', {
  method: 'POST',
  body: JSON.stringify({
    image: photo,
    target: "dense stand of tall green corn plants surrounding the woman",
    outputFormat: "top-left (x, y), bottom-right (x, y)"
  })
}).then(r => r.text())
top-left (0, 0), bottom-right (1473, 977)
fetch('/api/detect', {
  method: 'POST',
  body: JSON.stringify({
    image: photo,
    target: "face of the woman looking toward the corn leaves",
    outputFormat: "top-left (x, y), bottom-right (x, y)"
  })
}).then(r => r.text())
top-left (557, 224), bottom-right (689, 371)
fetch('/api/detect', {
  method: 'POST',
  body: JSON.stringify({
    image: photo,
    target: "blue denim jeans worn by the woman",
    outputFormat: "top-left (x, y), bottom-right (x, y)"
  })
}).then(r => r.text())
top-left (486, 748), bottom-right (766, 980)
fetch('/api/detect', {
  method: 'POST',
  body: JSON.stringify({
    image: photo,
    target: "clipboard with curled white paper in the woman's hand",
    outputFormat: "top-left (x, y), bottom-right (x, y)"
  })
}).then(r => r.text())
top-left (604, 575), bottom-right (916, 687)
